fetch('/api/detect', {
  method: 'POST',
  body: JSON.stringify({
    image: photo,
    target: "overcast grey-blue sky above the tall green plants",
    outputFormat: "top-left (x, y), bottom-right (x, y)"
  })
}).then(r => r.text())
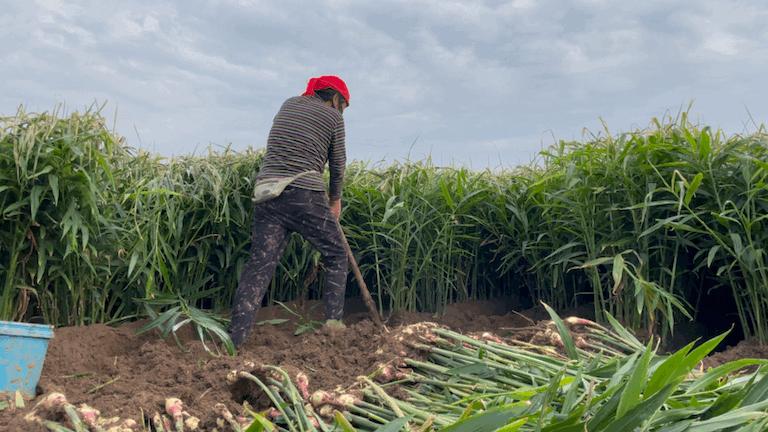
top-left (0, 0), bottom-right (768, 168)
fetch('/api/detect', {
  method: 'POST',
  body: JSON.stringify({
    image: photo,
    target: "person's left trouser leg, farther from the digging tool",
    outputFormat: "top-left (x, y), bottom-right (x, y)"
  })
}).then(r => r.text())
top-left (229, 209), bottom-right (287, 346)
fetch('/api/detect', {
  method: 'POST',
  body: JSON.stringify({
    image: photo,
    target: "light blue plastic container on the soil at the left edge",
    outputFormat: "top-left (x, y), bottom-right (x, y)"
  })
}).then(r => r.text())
top-left (0, 321), bottom-right (53, 399)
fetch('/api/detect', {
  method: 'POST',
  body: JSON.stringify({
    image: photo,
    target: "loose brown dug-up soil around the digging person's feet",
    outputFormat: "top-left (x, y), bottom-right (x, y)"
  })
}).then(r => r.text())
top-left (0, 301), bottom-right (544, 431)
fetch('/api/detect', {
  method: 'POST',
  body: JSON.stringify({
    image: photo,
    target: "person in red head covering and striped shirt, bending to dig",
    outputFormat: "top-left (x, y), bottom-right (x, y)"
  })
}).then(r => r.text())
top-left (229, 76), bottom-right (349, 346)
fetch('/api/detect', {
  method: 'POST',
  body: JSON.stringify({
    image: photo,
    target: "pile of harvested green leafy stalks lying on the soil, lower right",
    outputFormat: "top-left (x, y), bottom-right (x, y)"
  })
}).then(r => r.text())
top-left (258, 317), bottom-right (768, 432)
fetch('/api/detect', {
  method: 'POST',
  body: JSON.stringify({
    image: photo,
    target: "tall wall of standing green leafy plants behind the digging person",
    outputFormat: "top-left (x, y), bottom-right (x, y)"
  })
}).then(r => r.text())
top-left (0, 106), bottom-right (768, 341)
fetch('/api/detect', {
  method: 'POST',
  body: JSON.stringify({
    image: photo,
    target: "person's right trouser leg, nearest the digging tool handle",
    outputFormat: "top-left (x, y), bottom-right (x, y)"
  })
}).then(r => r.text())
top-left (289, 191), bottom-right (349, 320)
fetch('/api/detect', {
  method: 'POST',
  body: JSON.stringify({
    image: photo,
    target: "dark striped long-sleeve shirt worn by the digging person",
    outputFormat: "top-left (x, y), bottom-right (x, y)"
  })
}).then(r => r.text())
top-left (256, 96), bottom-right (347, 200)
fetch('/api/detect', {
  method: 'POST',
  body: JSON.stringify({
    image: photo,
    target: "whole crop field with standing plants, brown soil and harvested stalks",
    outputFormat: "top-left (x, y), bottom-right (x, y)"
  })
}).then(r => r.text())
top-left (0, 105), bottom-right (768, 432)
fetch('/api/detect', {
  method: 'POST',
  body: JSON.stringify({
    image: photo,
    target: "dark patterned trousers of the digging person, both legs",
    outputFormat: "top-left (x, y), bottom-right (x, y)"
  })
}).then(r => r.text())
top-left (229, 187), bottom-right (348, 345)
